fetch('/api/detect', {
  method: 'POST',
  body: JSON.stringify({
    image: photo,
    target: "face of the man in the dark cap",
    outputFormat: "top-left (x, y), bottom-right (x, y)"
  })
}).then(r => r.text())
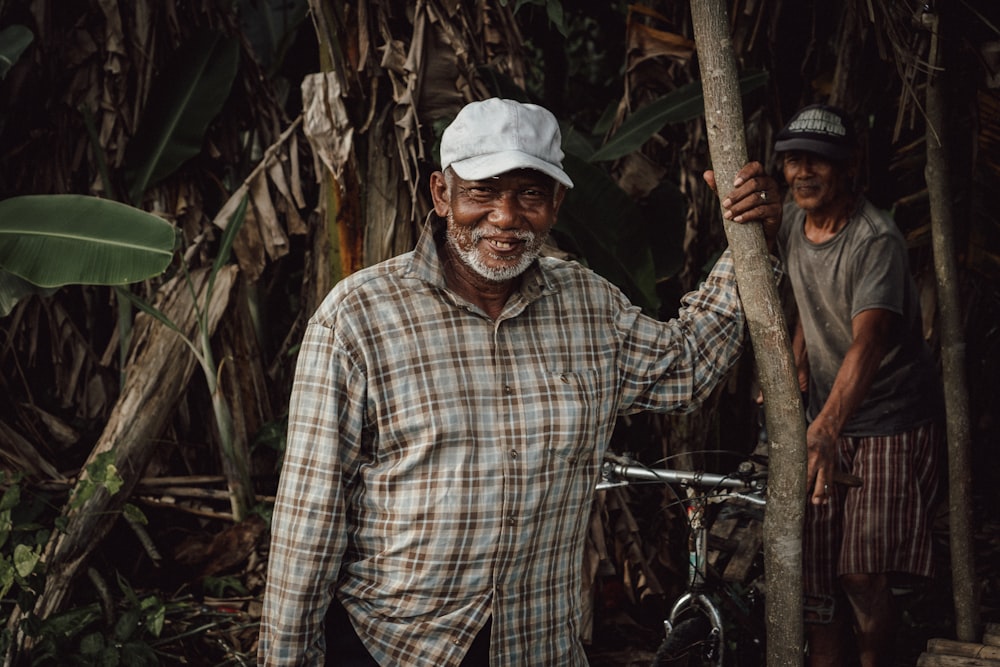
top-left (782, 151), bottom-right (853, 215)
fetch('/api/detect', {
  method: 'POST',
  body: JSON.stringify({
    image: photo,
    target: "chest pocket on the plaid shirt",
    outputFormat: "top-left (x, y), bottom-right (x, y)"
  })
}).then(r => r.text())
top-left (523, 370), bottom-right (601, 464)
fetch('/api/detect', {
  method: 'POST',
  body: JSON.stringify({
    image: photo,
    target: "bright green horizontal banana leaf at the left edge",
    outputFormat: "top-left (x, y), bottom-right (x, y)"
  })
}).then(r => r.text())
top-left (0, 195), bottom-right (176, 287)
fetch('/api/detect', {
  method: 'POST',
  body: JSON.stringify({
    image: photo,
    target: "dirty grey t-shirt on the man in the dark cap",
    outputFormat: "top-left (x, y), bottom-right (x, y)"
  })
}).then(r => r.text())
top-left (778, 199), bottom-right (941, 436)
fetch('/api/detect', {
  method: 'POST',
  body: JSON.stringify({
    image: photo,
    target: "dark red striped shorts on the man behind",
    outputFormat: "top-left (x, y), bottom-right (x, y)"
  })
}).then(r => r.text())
top-left (802, 424), bottom-right (941, 597)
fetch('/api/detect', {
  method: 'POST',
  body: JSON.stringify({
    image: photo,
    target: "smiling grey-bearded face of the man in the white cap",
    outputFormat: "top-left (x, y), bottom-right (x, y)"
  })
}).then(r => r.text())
top-left (431, 169), bottom-right (565, 283)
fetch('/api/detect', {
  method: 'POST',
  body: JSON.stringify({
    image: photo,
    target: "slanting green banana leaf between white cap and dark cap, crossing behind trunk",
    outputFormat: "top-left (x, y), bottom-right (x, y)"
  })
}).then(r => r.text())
top-left (588, 72), bottom-right (769, 162)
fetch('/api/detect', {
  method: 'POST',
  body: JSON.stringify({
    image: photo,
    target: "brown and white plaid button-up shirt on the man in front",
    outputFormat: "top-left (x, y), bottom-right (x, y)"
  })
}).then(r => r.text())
top-left (260, 220), bottom-right (744, 667)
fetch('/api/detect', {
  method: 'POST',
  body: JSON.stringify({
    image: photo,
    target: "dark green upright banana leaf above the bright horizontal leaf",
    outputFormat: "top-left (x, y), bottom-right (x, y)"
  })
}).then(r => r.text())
top-left (125, 30), bottom-right (240, 203)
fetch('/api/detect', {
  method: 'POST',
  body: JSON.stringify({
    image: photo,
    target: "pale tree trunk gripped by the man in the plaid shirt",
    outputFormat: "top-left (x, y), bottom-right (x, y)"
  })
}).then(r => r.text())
top-left (691, 0), bottom-right (806, 665)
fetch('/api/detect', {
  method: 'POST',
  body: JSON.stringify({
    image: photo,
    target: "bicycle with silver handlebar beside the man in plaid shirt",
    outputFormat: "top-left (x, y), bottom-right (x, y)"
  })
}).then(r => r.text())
top-left (598, 454), bottom-right (767, 667)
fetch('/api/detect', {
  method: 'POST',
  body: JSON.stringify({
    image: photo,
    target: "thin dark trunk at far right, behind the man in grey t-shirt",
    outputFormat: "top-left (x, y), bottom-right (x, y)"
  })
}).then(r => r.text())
top-left (923, 13), bottom-right (979, 642)
